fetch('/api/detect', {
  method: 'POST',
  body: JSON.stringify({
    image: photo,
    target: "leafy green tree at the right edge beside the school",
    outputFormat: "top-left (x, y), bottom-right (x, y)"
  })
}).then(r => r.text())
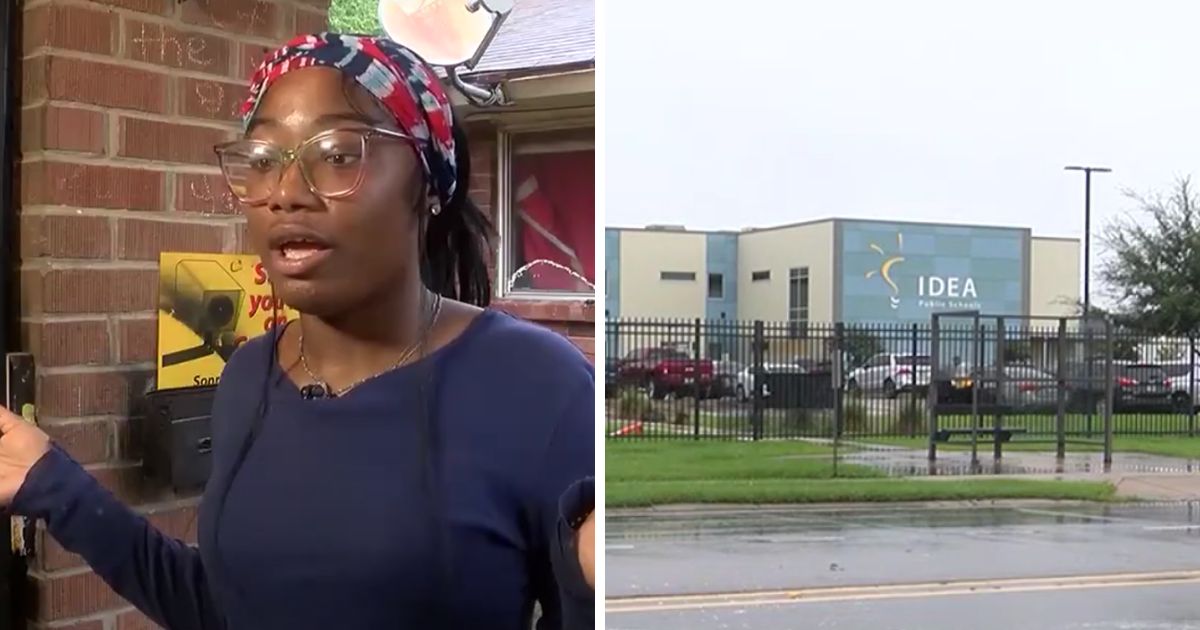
top-left (1100, 178), bottom-right (1200, 335)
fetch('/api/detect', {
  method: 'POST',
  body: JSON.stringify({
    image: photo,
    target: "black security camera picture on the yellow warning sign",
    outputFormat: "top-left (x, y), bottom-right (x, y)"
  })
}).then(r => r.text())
top-left (158, 260), bottom-right (246, 367)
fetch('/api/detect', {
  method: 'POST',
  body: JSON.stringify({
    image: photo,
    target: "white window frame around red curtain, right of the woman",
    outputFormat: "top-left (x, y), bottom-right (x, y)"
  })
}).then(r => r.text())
top-left (496, 122), bottom-right (601, 301)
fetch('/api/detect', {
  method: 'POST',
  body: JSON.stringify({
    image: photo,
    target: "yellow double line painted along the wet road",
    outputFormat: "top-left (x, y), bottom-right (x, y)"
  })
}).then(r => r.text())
top-left (605, 570), bottom-right (1200, 614)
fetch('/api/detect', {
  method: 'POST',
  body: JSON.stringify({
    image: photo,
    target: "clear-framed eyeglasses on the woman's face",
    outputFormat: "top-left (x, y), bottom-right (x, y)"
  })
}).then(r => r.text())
top-left (214, 127), bottom-right (421, 205)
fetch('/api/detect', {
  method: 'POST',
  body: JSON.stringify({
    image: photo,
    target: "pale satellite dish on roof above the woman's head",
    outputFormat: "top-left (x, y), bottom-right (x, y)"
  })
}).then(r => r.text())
top-left (379, 0), bottom-right (512, 70)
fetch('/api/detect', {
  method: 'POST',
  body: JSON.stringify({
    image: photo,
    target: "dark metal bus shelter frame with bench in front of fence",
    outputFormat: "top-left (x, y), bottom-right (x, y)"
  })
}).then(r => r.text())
top-left (928, 311), bottom-right (1116, 469)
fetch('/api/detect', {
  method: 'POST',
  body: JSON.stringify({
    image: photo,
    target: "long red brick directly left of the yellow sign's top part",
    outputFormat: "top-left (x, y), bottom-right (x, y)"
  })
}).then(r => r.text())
top-left (20, 269), bottom-right (158, 314)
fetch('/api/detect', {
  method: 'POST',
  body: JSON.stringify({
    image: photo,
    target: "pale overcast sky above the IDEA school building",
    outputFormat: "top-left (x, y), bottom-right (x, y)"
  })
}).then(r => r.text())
top-left (602, 0), bottom-right (1200, 274)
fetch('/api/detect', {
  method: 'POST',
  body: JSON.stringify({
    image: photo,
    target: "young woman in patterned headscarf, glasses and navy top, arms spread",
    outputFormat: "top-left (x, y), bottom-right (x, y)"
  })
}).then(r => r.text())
top-left (0, 34), bottom-right (595, 630)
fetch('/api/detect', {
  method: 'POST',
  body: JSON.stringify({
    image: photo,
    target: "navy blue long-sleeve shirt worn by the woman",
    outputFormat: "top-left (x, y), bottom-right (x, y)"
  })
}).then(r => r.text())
top-left (12, 311), bottom-right (595, 630)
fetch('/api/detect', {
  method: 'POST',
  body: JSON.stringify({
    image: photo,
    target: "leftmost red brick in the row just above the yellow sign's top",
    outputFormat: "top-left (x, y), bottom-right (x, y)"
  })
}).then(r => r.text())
top-left (20, 215), bottom-right (113, 260)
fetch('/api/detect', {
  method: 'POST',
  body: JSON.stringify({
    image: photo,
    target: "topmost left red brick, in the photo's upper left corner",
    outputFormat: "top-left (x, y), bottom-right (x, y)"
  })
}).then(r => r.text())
top-left (23, 4), bottom-right (118, 55)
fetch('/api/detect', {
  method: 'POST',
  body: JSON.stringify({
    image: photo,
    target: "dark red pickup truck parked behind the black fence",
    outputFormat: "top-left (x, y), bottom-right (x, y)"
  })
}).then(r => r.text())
top-left (617, 348), bottom-right (714, 398)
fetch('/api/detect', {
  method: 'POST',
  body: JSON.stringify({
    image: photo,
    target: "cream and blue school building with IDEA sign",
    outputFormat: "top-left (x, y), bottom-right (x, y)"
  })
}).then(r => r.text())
top-left (605, 218), bottom-right (1082, 328)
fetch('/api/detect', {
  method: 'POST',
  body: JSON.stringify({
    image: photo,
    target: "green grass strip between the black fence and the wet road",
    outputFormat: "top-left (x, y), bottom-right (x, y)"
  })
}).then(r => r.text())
top-left (605, 440), bottom-right (1114, 508)
